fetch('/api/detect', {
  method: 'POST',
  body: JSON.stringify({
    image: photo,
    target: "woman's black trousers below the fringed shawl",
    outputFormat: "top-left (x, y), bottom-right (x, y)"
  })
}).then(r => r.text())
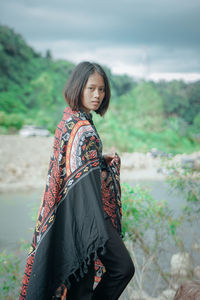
top-left (66, 219), bottom-right (135, 300)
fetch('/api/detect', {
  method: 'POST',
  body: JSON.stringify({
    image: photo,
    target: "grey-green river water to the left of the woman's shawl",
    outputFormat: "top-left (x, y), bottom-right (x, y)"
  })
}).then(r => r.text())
top-left (0, 190), bottom-right (42, 250)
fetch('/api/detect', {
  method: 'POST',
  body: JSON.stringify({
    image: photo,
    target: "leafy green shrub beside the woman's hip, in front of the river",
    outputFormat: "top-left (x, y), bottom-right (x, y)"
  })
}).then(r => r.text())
top-left (122, 184), bottom-right (180, 285)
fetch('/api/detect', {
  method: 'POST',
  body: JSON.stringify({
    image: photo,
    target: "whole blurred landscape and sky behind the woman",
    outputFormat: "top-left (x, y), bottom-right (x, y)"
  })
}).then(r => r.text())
top-left (0, 0), bottom-right (200, 300)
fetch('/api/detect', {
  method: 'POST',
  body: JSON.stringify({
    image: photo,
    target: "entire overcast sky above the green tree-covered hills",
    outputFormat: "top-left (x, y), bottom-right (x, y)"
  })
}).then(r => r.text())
top-left (0, 0), bottom-right (200, 80)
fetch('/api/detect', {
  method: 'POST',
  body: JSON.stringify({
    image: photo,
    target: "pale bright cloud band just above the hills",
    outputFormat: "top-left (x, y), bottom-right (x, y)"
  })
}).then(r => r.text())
top-left (30, 40), bottom-right (200, 77)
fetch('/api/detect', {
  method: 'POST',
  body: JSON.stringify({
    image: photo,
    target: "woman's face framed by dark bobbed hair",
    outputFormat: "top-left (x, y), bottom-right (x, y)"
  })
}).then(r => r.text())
top-left (81, 71), bottom-right (105, 113)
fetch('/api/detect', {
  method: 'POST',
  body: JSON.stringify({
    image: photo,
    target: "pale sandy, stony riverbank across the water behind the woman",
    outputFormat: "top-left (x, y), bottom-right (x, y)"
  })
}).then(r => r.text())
top-left (0, 135), bottom-right (200, 192)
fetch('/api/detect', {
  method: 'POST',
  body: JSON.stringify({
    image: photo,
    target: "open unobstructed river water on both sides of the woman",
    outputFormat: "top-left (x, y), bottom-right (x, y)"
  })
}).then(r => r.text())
top-left (0, 180), bottom-right (187, 250)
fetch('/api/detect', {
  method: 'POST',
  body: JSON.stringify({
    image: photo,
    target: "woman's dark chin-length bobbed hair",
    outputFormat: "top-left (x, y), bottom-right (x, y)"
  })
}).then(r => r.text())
top-left (64, 61), bottom-right (110, 116)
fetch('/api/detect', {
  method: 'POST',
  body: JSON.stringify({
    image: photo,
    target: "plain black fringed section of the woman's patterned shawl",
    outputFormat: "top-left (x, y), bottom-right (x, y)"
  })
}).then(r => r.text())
top-left (26, 169), bottom-right (107, 300)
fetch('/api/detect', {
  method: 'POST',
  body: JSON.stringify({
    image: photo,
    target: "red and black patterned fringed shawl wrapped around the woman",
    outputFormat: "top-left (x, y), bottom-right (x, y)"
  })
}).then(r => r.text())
top-left (19, 107), bottom-right (121, 300)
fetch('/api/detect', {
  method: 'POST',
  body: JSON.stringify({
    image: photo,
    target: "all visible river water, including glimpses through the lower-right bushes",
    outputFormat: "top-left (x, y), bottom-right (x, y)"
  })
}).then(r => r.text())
top-left (0, 180), bottom-right (200, 294)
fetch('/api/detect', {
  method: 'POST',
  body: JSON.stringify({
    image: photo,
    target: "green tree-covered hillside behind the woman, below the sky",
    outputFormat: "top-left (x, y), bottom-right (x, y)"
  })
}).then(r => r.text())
top-left (0, 26), bottom-right (200, 154)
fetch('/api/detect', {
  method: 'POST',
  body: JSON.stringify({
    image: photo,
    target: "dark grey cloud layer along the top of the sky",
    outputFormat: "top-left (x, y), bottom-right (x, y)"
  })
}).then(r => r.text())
top-left (1, 0), bottom-right (200, 45)
